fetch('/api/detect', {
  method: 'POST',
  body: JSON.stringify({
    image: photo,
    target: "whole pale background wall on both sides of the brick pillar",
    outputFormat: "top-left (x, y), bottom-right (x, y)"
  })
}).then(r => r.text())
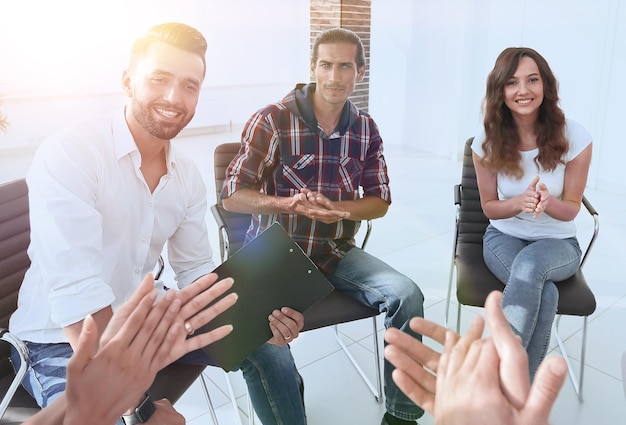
top-left (0, 0), bottom-right (626, 193)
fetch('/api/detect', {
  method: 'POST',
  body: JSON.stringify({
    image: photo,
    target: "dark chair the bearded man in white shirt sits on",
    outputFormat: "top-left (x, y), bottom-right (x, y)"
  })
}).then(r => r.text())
top-left (0, 179), bottom-right (204, 425)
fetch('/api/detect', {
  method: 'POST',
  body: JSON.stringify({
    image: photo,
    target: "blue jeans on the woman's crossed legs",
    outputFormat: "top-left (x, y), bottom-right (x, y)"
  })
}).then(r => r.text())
top-left (483, 225), bottom-right (581, 379)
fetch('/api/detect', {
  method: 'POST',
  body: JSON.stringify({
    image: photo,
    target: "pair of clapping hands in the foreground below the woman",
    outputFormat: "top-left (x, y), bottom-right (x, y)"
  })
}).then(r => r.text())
top-left (385, 291), bottom-right (567, 425)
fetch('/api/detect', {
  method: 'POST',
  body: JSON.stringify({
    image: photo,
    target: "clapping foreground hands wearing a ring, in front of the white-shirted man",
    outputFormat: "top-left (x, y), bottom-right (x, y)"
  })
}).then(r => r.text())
top-left (25, 274), bottom-right (237, 425)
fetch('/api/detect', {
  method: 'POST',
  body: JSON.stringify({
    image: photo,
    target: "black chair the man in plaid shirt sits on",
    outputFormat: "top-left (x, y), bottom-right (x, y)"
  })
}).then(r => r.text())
top-left (211, 142), bottom-right (382, 403)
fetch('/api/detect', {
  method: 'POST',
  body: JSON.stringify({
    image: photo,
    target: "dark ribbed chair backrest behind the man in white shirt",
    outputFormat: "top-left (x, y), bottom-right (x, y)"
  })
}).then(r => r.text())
top-left (0, 179), bottom-right (30, 378)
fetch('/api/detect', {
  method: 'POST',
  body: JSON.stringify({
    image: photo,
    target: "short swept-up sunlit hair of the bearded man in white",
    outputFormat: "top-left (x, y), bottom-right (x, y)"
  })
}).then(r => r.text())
top-left (130, 22), bottom-right (207, 73)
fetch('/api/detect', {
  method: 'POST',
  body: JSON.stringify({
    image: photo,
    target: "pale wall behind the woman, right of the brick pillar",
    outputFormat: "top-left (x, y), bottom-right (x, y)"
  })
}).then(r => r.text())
top-left (370, 0), bottom-right (626, 192)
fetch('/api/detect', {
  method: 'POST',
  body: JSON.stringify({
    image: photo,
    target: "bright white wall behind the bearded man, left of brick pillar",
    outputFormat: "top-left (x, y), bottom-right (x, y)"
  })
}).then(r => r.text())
top-left (0, 0), bottom-right (310, 147)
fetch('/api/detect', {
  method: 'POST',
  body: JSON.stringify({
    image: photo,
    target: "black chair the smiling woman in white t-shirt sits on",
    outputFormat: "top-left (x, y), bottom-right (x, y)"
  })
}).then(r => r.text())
top-left (445, 137), bottom-right (599, 402)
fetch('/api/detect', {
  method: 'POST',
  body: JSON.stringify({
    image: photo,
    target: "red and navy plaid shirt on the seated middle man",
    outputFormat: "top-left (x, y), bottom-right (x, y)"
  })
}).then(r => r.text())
top-left (220, 83), bottom-right (391, 272)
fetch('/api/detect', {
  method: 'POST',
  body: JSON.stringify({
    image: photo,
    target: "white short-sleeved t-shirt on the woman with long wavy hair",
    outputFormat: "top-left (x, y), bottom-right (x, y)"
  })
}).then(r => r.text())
top-left (472, 119), bottom-right (592, 240)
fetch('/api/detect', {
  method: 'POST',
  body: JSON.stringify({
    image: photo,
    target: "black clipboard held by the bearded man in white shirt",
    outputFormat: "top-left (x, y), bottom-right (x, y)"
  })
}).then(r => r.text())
top-left (196, 223), bottom-right (334, 372)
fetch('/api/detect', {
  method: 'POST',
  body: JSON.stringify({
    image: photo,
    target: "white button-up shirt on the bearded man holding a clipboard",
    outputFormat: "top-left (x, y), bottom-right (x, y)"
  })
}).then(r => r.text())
top-left (9, 111), bottom-right (215, 343)
